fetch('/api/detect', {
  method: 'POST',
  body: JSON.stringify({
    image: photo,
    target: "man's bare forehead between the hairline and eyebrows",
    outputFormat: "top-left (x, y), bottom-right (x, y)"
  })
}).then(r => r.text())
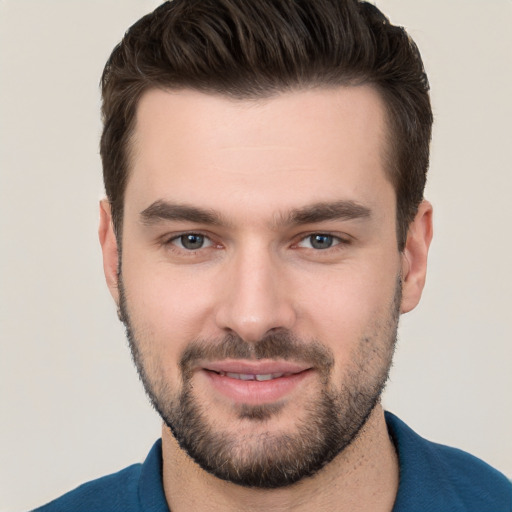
top-left (125, 86), bottom-right (394, 222)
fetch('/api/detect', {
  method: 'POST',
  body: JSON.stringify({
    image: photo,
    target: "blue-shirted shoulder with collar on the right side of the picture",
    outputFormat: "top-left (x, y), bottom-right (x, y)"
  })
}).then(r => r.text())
top-left (386, 413), bottom-right (512, 512)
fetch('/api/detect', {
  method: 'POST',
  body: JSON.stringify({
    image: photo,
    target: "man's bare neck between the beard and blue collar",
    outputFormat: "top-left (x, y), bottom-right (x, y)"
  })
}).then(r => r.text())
top-left (162, 405), bottom-right (398, 512)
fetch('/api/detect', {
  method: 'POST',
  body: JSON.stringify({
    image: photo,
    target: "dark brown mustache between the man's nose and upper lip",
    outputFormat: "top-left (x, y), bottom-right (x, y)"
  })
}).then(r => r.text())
top-left (180, 330), bottom-right (334, 375)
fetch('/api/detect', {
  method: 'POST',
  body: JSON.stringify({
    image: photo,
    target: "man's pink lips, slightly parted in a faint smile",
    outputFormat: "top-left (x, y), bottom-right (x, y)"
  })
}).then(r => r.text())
top-left (198, 360), bottom-right (313, 405)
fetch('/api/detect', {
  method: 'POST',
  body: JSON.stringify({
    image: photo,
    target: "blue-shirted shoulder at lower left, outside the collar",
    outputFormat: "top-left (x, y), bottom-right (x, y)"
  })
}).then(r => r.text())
top-left (34, 464), bottom-right (142, 512)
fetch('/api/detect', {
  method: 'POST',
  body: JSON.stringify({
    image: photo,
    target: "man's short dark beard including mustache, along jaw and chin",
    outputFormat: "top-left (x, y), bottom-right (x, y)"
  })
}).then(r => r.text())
top-left (119, 275), bottom-right (402, 489)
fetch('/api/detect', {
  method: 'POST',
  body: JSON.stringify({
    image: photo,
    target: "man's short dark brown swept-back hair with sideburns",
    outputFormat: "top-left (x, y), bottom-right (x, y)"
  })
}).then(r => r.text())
top-left (100, 0), bottom-right (433, 250)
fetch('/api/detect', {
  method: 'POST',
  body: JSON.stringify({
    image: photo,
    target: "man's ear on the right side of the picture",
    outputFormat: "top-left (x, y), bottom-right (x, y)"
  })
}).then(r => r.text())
top-left (400, 201), bottom-right (433, 313)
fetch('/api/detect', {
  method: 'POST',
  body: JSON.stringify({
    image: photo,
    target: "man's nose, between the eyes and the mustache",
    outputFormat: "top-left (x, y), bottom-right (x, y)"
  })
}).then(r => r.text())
top-left (216, 245), bottom-right (296, 342)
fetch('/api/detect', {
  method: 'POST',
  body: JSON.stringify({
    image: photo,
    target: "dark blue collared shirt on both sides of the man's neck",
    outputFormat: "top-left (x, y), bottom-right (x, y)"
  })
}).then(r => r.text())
top-left (35, 412), bottom-right (512, 512)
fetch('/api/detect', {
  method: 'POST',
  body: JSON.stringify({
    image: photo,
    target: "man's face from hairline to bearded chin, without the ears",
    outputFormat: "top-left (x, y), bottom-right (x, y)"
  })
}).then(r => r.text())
top-left (101, 86), bottom-right (420, 487)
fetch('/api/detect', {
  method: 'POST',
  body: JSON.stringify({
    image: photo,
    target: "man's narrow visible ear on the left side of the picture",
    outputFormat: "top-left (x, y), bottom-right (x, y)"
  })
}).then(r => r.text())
top-left (98, 199), bottom-right (119, 305)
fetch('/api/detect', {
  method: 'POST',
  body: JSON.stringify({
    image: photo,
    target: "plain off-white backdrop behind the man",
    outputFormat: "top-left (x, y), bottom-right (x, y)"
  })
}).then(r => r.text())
top-left (0, 0), bottom-right (512, 512)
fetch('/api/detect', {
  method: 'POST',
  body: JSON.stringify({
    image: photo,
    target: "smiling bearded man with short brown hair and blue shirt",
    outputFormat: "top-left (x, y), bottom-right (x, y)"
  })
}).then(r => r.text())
top-left (34, 0), bottom-right (512, 512)
